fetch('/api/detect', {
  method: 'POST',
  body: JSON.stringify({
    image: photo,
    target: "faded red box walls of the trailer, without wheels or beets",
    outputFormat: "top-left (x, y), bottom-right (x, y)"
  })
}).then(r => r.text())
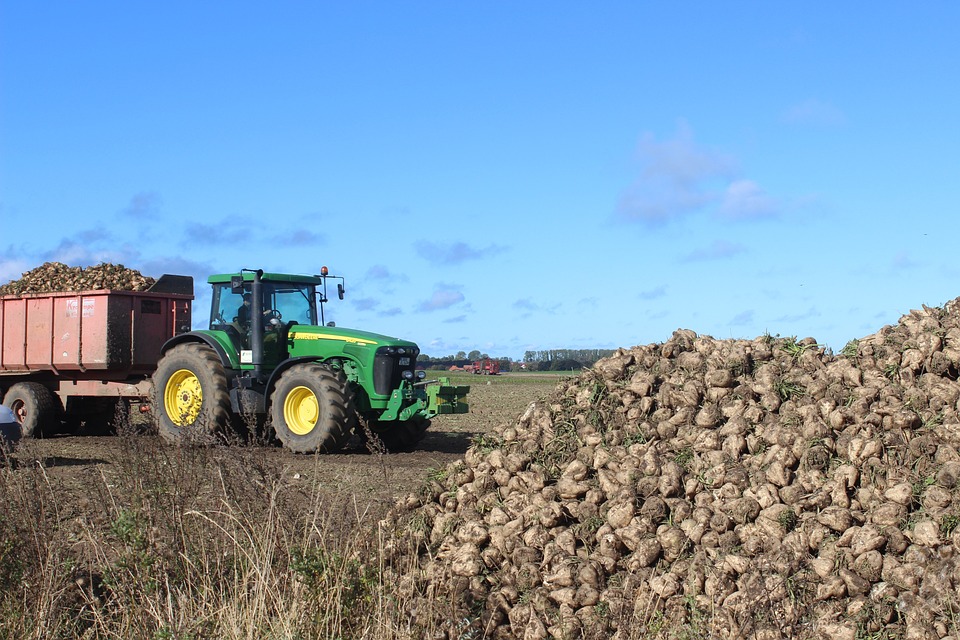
top-left (0, 290), bottom-right (193, 379)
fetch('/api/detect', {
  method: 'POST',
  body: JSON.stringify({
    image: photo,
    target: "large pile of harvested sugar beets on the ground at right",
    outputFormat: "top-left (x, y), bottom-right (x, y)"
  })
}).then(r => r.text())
top-left (381, 299), bottom-right (960, 640)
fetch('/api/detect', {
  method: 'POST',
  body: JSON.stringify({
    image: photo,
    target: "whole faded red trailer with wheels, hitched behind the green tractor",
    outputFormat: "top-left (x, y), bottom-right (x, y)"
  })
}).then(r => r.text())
top-left (0, 275), bottom-right (193, 436)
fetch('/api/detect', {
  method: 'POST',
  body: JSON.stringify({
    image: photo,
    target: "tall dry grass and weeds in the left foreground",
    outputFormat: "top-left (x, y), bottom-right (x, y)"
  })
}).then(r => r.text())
top-left (0, 428), bottom-right (432, 639)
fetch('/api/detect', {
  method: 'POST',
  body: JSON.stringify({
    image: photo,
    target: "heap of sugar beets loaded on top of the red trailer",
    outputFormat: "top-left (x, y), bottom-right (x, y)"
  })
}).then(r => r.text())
top-left (0, 262), bottom-right (156, 296)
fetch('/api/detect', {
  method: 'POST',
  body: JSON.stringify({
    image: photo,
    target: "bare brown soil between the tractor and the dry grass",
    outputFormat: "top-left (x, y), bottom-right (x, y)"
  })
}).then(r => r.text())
top-left (11, 374), bottom-right (560, 522)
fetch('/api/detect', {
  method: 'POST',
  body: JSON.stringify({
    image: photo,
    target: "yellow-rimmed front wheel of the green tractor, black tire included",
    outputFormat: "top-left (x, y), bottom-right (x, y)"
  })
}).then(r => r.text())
top-left (270, 363), bottom-right (357, 453)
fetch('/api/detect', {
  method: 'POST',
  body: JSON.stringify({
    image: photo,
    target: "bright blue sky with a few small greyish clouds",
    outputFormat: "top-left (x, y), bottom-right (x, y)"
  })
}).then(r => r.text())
top-left (0, 0), bottom-right (960, 358)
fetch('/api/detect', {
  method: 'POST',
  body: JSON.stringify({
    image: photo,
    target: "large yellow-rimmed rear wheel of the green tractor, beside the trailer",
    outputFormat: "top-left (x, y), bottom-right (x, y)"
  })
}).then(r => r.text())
top-left (153, 342), bottom-right (231, 444)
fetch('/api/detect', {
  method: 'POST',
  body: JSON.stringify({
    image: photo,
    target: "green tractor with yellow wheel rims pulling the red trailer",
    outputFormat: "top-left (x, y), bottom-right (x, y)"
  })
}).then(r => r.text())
top-left (153, 267), bottom-right (470, 453)
